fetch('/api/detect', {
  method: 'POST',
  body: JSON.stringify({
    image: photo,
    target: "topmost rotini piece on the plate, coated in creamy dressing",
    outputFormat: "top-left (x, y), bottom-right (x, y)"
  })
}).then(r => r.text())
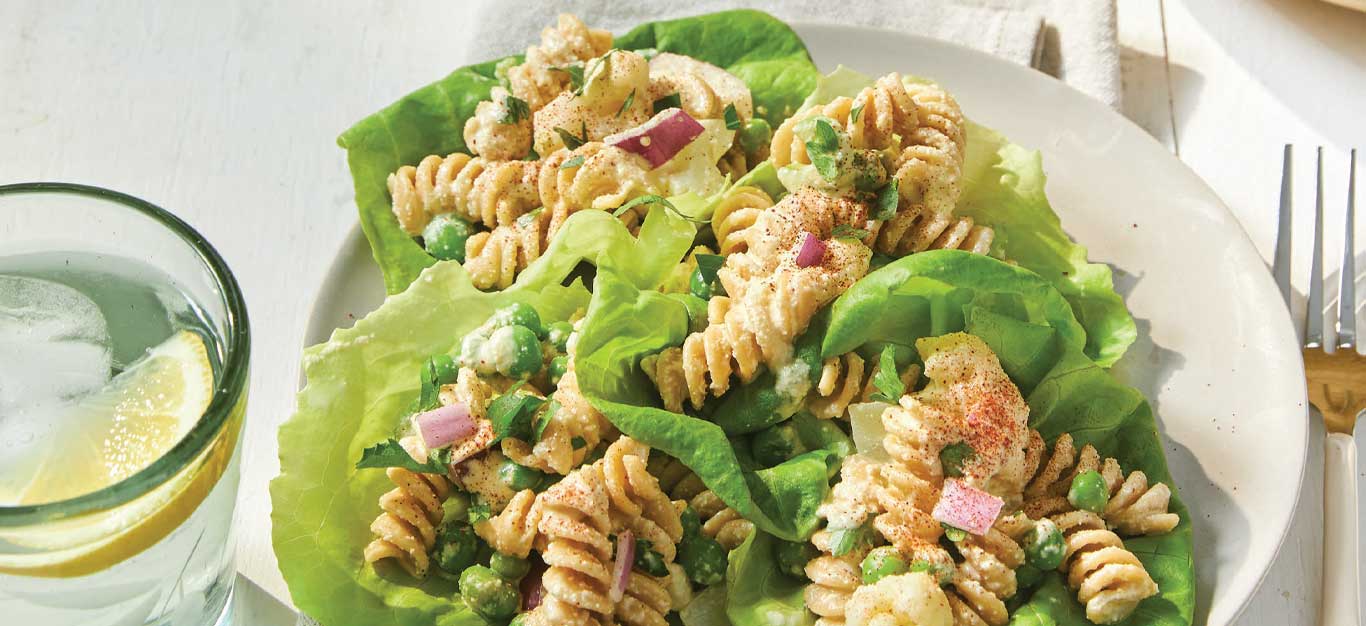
top-left (507, 14), bottom-right (612, 111)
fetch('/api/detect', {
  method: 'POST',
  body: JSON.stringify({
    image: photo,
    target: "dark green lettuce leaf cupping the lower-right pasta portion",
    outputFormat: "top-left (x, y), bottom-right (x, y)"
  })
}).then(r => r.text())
top-left (727, 250), bottom-right (1195, 626)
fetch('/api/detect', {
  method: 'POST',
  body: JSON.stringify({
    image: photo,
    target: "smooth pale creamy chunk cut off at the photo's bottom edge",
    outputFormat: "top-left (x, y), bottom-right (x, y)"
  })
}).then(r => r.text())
top-left (846, 573), bottom-right (953, 626)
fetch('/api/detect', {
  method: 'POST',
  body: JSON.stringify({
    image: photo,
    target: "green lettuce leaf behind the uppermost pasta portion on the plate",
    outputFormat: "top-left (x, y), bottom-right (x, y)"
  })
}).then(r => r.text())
top-left (337, 10), bottom-right (820, 294)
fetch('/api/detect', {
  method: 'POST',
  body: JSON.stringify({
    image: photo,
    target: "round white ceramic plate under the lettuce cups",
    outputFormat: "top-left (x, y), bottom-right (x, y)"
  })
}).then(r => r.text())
top-left (306, 25), bottom-right (1309, 625)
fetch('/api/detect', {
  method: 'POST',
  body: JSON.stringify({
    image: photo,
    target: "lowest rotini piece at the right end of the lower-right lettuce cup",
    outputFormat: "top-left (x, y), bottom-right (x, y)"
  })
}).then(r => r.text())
top-left (1052, 511), bottom-right (1157, 623)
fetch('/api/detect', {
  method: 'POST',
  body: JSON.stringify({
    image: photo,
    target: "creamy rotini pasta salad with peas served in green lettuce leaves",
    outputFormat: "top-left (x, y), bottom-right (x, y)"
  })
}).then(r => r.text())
top-left (272, 11), bottom-right (1194, 626)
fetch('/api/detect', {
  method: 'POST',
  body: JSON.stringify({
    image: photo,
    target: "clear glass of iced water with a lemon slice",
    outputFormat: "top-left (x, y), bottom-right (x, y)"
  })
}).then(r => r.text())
top-left (0, 183), bottom-right (249, 626)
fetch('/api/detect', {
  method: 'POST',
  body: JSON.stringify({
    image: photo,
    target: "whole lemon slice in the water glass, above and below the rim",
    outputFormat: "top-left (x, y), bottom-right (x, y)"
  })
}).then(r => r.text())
top-left (0, 331), bottom-right (246, 577)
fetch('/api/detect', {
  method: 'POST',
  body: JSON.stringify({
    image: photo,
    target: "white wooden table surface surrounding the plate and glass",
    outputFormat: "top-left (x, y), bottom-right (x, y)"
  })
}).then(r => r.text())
top-left (0, 0), bottom-right (1366, 626)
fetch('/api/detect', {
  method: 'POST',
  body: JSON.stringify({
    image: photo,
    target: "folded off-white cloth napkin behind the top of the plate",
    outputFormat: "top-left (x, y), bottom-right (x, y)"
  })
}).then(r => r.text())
top-left (464, 0), bottom-right (1120, 108)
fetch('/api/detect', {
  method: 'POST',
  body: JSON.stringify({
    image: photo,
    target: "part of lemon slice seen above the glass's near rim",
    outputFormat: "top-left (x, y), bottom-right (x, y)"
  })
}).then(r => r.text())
top-left (19, 331), bottom-right (213, 504)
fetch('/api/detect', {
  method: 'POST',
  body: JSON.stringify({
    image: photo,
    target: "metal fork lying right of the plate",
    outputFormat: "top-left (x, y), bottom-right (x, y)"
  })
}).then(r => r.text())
top-left (1274, 145), bottom-right (1366, 626)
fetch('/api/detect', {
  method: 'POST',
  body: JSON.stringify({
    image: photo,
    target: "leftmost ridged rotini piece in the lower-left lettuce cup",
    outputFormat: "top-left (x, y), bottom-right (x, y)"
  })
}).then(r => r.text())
top-left (365, 440), bottom-right (451, 578)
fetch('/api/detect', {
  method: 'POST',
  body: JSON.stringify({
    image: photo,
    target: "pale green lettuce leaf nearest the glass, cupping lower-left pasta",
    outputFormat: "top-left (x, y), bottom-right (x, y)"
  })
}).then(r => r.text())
top-left (270, 262), bottom-right (589, 626)
